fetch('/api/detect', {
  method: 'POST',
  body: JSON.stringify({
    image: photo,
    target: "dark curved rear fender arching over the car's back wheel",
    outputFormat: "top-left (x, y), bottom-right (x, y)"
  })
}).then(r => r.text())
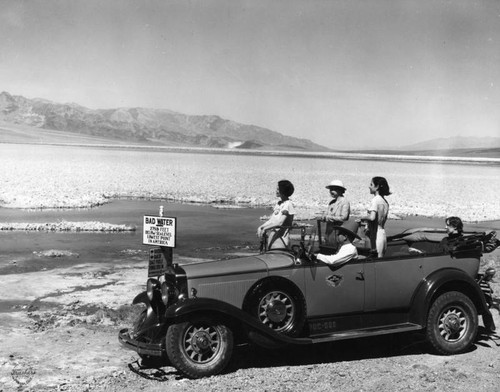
top-left (410, 268), bottom-right (495, 331)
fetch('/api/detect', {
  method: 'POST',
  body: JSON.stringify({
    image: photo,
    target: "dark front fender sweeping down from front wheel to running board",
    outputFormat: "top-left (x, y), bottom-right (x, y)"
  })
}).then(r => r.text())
top-left (165, 298), bottom-right (312, 344)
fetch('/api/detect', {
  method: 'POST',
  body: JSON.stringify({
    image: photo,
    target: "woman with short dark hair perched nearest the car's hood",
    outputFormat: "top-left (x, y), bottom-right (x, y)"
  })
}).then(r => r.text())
top-left (257, 180), bottom-right (295, 249)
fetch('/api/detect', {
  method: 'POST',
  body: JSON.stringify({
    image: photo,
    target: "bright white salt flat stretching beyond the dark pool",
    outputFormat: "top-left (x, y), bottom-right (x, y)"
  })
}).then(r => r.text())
top-left (0, 144), bottom-right (500, 221)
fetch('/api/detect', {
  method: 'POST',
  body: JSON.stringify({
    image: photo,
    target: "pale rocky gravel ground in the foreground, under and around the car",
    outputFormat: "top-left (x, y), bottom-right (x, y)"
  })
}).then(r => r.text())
top-left (0, 251), bottom-right (500, 392)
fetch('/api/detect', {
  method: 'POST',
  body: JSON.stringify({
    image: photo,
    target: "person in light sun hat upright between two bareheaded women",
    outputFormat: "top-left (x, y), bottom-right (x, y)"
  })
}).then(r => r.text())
top-left (322, 180), bottom-right (351, 245)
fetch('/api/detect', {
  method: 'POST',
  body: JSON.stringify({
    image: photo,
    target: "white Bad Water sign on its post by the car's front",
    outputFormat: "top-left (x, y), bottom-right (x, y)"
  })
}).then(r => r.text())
top-left (142, 206), bottom-right (177, 277)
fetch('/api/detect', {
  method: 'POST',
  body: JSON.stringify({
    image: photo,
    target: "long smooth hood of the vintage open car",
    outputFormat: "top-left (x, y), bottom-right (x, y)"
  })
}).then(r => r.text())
top-left (182, 252), bottom-right (293, 279)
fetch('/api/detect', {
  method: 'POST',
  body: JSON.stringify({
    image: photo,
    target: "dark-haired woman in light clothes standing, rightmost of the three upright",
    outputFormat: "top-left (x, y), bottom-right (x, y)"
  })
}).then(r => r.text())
top-left (361, 177), bottom-right (391, 257)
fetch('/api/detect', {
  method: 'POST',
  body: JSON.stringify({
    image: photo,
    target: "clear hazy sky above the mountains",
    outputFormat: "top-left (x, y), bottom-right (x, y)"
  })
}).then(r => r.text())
top-left (0, 0), bottom-right (500, 148)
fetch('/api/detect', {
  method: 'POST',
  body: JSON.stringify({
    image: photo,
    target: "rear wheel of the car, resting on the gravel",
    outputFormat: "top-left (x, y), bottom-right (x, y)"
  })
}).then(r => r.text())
top-left (426, 291), bottom-right (478, 355)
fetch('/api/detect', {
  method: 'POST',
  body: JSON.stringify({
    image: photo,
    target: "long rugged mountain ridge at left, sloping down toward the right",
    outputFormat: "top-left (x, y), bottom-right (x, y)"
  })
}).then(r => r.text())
top-left (0, 92), bottom-right (330, 151)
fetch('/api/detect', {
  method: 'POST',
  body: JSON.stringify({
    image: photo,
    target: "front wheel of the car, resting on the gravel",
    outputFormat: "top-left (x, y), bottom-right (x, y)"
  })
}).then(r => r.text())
top-left (166, 317), bottom-right (233, 378)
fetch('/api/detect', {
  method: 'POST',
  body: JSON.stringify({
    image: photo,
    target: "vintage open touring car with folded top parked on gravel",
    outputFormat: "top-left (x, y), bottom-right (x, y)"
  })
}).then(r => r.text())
top-left (119, 222), bottom-right (495, 378)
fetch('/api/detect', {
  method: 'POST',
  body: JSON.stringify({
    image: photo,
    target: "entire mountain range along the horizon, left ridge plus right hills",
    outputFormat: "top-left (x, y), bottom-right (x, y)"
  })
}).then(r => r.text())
top-left (0, 92), bottom-right (500, 158)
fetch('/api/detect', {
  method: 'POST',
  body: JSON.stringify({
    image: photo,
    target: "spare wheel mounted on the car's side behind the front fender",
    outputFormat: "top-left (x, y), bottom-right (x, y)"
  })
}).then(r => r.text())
top-left (248, 281), bottom-right (305, 337)
